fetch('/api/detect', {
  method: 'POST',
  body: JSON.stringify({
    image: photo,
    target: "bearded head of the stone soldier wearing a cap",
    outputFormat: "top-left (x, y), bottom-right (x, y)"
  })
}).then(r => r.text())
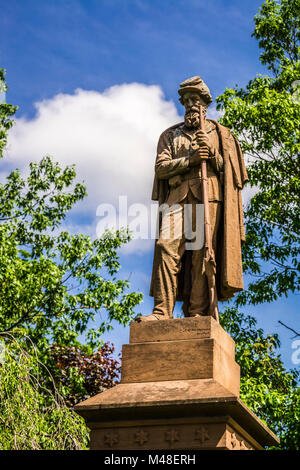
top-left (178, 77), bottom-right (212, 127)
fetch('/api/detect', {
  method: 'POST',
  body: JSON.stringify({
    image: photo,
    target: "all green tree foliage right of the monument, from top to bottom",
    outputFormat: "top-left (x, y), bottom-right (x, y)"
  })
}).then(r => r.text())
top-left (217, 0), bottom-right (300, 450)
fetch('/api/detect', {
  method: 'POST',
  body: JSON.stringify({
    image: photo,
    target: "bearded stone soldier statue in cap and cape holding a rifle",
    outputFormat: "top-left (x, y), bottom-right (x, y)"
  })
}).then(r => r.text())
top-left (137, 76), bottom-right (247, 321)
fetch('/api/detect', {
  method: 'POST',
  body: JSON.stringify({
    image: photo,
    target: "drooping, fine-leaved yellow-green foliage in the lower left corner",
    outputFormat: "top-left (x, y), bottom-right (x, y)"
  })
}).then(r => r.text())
top-left (0, 335), bottom-right (88, 450)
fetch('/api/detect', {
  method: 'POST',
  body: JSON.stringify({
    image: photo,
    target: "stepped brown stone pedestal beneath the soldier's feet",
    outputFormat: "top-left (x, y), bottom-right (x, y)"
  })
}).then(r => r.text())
top-left (75, 317), bottom-right (278, 450)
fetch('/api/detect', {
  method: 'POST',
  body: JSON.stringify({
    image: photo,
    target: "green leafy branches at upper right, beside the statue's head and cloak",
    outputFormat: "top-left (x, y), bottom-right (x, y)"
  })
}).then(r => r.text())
top-left (217, 0), bottom-right (300, 305)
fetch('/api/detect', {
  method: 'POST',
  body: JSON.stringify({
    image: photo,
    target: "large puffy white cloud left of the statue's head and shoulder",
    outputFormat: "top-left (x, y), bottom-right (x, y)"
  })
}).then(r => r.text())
top-left (7, 83), bottom-right (180, 214)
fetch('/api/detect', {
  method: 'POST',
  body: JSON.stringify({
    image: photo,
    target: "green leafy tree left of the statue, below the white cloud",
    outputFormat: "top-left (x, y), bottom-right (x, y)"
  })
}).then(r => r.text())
top-left (0, 157), bottom-right (141, 350)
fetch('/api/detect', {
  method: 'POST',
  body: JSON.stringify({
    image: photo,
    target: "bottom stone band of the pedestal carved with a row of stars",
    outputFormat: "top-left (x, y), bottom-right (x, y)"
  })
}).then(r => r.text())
top-left (91, 417), bottom-right (255, 450)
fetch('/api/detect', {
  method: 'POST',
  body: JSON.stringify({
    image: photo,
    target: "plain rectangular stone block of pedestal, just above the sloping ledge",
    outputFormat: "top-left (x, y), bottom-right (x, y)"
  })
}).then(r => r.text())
top-left (122, 339), bottom-right (240, 395)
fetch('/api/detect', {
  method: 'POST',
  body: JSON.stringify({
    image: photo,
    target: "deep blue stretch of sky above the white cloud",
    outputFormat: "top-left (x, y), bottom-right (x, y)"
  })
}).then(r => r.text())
top-left (0, 0), bottom-right (262, 114)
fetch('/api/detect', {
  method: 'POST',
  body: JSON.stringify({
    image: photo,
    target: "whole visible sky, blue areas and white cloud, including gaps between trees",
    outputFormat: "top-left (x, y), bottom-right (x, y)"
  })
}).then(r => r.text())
top-left (0, 0), bottom-right (298, 367)
